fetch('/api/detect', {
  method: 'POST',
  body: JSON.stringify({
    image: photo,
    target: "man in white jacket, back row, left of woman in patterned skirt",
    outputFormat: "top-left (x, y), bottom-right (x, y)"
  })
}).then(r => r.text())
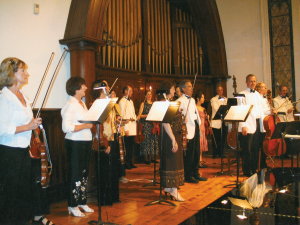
top-left (119, 85), bottom-right (136, 169)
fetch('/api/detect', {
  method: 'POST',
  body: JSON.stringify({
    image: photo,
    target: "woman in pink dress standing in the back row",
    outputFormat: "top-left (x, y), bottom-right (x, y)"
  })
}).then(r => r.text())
top-left (195, 90), bottom-right (210, 168)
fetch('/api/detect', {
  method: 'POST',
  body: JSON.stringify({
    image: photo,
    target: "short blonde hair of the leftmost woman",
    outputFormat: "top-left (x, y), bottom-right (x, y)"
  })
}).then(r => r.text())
top-left (0, 57), bottom-right (27, 90)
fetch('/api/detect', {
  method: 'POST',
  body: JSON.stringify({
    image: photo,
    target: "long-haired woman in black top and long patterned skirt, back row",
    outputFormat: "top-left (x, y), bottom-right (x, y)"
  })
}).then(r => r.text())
top-left (137, 90), bottom-right (158, 164)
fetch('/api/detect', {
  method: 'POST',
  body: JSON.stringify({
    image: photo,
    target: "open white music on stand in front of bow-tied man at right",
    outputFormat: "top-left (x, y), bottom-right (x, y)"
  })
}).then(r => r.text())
top-left (224, 105), bottom-right (253, 122)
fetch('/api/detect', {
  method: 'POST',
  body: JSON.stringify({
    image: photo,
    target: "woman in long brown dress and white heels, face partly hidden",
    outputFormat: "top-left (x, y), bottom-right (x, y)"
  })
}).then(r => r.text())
top-left (157, 81), bottom-right (184, 202)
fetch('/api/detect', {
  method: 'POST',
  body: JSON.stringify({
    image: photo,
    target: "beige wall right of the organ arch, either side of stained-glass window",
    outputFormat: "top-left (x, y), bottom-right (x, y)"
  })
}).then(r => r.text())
top-left (216, 0), bottom-right (300, 98)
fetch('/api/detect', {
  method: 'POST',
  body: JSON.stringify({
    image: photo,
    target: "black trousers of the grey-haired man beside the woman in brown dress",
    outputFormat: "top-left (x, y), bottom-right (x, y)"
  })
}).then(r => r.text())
top-left (184, 121), bottom-right (200, 179)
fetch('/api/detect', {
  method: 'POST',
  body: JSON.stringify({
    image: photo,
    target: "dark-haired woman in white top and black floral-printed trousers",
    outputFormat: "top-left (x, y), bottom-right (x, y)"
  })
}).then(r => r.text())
top-left (61, 77), bottom-right (94, 217)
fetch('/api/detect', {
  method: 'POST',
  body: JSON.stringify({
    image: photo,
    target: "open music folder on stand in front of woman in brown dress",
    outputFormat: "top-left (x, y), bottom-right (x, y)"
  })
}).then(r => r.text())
top-left (146, 101), bottom-right (180, 123)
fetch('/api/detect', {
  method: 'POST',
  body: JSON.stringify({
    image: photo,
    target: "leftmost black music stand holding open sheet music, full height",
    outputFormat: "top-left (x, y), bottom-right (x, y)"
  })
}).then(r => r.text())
top-left (78, 98), bottom-right (118, 225)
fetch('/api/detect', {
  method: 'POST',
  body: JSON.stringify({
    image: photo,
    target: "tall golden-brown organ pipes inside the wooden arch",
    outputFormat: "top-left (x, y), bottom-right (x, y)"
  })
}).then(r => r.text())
top-left (97, 0), bottom-right (203, 75)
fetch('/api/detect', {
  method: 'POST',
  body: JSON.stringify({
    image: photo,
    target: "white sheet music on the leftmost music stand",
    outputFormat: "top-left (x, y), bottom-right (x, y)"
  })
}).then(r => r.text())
top-left (83, 98), bottom-right (118, 121)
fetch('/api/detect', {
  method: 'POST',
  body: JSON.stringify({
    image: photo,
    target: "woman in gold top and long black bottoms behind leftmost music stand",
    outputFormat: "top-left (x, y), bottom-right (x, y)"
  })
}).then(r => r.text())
top-left (93, 80), bottom-right (121, 205)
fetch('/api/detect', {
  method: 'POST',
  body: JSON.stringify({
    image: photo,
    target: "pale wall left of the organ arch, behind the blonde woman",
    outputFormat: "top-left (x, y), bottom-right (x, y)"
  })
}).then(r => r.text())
top-left (0, 0), bottom-right (71, 108)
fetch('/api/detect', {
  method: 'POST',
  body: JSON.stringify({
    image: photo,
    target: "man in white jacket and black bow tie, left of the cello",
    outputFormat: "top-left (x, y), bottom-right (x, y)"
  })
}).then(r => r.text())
top-left (238, 74), bottom-right (263, 176)
